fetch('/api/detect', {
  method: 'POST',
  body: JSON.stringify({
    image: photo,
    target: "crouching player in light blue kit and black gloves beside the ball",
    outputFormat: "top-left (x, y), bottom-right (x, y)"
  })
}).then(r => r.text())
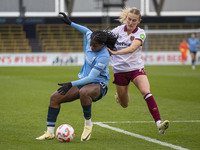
top-left (36, 12), bottom-right (117, 141)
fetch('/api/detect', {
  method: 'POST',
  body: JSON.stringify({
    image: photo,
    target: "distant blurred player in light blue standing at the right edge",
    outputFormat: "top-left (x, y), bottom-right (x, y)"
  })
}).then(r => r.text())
top-left (188, 33), bottom-right (199, 70)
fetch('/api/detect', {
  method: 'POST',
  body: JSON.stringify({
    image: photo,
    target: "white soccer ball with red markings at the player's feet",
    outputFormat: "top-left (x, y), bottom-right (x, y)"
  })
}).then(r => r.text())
top-left (56, 124), bottom-right (75, 142)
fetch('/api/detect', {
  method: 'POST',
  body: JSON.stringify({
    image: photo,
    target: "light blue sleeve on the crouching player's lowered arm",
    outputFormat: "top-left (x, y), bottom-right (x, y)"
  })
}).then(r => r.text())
top-left (71, 68), bottom-right (100, 86)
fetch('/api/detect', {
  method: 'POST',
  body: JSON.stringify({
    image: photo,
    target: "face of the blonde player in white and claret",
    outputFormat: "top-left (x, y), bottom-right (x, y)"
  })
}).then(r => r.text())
top-left (126, 13), bottom-right (141, 32)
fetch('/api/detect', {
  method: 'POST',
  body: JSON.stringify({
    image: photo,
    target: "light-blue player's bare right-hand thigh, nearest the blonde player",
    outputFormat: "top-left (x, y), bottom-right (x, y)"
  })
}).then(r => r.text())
top-left (79, 83), bottom-right (101, 99)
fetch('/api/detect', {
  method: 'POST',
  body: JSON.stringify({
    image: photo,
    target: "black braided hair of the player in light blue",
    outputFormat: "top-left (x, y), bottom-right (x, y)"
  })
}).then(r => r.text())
top-left (91, 30), bottom-right (118, 49)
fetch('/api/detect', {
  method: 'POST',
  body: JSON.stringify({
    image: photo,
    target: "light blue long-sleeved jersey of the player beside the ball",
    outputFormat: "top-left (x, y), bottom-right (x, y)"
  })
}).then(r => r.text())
top-left (71, 22), bottom-right (110, 85)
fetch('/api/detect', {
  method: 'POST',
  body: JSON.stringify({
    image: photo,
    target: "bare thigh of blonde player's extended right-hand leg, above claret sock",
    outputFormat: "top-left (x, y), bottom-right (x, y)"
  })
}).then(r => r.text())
top-left (133, 75), bottom-right (150, 96)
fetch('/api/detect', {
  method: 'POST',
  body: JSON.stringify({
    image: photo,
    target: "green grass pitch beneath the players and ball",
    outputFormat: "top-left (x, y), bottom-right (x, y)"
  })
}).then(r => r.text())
top-left (0, 65), bottom-right (200, 150)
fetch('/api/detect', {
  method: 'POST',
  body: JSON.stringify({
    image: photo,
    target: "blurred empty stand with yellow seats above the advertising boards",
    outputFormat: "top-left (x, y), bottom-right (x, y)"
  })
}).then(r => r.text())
top-left (0, 0), bottom-right (200, 65)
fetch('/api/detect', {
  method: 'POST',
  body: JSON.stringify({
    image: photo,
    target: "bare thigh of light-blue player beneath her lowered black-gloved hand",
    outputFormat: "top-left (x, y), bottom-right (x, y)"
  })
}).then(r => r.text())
top-left (51, 86), bottom-right (80, 103)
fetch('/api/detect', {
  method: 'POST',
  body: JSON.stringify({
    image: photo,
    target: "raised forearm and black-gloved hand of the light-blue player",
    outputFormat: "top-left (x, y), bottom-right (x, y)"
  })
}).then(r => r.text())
top-left (59, 12), bottom-right (91, 34)
